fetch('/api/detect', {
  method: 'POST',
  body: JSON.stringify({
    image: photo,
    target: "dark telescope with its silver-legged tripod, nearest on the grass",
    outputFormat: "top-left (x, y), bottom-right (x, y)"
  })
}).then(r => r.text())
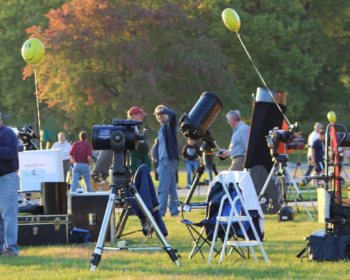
top-left (90, 120), bottom-right (180, 271)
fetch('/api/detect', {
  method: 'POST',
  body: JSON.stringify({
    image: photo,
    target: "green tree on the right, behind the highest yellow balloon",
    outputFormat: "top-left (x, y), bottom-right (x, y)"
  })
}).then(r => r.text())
top-left (196, 0), bottom-right (350, 124)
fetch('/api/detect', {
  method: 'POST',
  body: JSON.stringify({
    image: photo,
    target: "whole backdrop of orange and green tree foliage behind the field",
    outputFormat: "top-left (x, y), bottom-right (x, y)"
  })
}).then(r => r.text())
top-left (0, 0), bottom-right (350, 144)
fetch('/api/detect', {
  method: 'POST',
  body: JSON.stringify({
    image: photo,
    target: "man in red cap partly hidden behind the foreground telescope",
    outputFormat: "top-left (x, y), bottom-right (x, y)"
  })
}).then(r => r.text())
top-left (128, 107), bottom-right (152, 174)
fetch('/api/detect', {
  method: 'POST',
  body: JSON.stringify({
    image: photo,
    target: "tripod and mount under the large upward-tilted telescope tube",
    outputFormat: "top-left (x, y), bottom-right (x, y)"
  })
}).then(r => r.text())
top-left (184, 132), bottom-right (220, 204)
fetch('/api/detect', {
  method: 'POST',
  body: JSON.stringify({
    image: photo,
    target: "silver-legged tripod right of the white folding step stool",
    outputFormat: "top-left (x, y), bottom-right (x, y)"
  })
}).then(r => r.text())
top-left (258, 154), bottom-right (314, 222)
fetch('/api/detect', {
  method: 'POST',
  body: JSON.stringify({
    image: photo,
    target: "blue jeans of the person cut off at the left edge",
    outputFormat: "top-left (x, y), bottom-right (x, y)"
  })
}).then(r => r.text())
top-left (0, 172), bottom-right (19, 255)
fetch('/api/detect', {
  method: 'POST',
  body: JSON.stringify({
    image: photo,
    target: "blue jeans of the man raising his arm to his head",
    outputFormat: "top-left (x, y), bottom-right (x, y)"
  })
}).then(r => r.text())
top-left (157, 158), bottom-right (180, 216)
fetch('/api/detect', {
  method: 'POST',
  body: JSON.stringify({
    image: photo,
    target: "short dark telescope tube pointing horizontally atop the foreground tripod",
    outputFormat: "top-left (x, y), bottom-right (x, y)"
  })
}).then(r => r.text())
top-left (92, 120), bottom-right (148, 153)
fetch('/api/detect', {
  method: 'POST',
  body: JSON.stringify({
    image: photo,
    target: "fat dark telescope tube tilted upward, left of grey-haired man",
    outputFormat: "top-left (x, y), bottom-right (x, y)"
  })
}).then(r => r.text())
top-left (181, 92), bottom-right (224, 140)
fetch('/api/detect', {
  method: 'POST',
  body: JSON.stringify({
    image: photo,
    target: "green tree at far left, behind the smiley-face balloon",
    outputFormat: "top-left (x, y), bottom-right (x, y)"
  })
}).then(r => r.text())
top-left (0, 0), bottom-right (67, 125)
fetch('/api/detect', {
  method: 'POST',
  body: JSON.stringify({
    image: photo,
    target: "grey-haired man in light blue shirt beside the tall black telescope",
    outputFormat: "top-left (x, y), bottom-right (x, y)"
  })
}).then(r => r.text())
top-left (220, 110), bottom-right (250, 171)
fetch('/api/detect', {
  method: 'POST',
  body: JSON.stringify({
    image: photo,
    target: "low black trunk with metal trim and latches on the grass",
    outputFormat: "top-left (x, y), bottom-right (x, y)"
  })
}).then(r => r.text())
top-left (17, 215), bottom-right (74, 246)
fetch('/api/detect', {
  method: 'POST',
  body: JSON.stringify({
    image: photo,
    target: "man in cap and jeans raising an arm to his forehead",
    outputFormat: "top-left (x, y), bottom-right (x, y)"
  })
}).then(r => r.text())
top-left (154, 105), bottom-right (179, 217)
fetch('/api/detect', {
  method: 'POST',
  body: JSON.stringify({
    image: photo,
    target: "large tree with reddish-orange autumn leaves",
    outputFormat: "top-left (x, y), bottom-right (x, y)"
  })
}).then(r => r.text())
top-left (25, 0), bottom-right (234, 137)
